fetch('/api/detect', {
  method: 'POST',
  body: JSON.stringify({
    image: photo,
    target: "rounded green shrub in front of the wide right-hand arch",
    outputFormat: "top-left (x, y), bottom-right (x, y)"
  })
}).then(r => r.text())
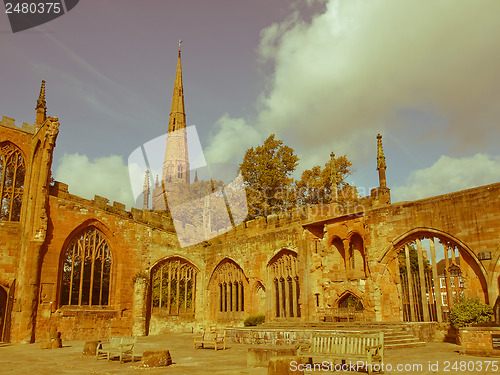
top-left (450, 298), bottom-right (493, 328)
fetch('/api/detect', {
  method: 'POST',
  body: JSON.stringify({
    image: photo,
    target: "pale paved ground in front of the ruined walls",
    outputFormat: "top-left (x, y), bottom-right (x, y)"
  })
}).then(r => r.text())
top-left (0, 334), bottom-right (500, 375)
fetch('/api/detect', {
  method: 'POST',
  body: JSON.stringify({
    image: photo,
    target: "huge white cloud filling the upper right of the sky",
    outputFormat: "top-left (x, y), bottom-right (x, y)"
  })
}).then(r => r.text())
top-left (205, 0), bottom-right (500, 168)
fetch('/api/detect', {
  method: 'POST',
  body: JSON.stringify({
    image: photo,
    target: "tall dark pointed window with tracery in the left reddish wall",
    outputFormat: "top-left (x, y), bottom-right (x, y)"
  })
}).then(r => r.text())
top-left (61, 226), bottom-right (112, 306)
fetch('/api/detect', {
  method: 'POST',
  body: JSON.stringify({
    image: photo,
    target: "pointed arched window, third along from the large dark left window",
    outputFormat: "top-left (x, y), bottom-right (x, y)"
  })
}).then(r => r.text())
top-left (208, 258), bottom-right (249, 320)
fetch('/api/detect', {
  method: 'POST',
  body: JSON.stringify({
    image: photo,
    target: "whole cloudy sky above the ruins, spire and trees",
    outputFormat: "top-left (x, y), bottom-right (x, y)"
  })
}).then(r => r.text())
top-left (0, 0), bottom-right (500, 207)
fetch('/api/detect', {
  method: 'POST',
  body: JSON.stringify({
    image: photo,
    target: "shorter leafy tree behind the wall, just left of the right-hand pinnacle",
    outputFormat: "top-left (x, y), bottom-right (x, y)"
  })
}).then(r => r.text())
top-left (295, 155), bottom-right (357, 205)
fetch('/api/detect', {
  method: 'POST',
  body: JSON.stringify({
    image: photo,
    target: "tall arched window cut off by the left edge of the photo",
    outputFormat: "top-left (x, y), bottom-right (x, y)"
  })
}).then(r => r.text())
top-left (0, 142), bottom-right (26, 221)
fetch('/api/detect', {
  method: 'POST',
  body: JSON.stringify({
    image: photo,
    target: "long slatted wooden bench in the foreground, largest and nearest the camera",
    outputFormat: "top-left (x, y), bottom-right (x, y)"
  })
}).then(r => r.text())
top-left (297, 332), bottom-right (384, 375)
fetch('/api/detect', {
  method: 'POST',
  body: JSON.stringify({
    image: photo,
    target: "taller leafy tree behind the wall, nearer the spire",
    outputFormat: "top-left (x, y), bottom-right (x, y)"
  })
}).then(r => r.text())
top-left (240, 134), bottom-right (299, 218)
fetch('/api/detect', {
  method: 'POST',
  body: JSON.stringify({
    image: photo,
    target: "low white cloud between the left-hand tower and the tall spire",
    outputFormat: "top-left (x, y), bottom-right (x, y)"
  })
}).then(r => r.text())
top-left (54, 153), bottom-right (137, 207)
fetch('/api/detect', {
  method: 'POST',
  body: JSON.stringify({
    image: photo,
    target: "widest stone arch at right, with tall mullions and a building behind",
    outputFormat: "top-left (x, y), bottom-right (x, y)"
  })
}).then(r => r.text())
top-left (376, 228), bottom-right (488, 322)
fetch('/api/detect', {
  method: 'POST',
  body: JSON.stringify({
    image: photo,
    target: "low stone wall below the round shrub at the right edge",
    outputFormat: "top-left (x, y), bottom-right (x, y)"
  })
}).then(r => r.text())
top-left (459, 327), bottom-right (500, 357)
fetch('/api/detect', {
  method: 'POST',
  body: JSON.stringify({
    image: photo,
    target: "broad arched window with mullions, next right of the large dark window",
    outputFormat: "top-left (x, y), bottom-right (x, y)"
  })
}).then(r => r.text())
top-left (149, 255), bottom-right (199, 317)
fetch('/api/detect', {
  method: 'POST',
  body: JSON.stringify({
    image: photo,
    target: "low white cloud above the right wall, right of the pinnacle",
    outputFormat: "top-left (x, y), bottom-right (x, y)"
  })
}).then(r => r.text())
top-left (391, 153), bottom-right (500, 202)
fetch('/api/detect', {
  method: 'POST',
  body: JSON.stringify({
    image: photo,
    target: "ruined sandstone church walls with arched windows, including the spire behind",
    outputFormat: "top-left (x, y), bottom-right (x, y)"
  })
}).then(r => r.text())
top-left (0, 47), bottom-right (500, 342)
